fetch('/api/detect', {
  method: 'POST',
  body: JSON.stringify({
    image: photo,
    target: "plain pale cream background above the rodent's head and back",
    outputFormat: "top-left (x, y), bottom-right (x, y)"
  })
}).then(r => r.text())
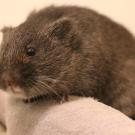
top-left (0, 0), bottom-right (135, 42)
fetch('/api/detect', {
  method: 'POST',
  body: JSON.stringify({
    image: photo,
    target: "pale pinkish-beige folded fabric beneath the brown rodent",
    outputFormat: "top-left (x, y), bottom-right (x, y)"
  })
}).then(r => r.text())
top-left (0, 90), bottom-right (135, 135)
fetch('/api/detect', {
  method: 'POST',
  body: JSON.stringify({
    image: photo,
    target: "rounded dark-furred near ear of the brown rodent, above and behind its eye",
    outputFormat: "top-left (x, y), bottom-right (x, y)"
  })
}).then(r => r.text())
top-left (49, 18), bottom-right (72, 39)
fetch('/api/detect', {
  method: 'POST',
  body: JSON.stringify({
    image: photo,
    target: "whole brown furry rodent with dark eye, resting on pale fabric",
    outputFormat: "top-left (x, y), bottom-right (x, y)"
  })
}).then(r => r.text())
top-left (0, 6), bottom-right (135, 117)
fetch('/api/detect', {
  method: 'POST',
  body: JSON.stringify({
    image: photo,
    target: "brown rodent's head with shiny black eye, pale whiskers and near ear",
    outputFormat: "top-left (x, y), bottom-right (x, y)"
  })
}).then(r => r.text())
top-left (0, 18), bottom-right (80, 99)
